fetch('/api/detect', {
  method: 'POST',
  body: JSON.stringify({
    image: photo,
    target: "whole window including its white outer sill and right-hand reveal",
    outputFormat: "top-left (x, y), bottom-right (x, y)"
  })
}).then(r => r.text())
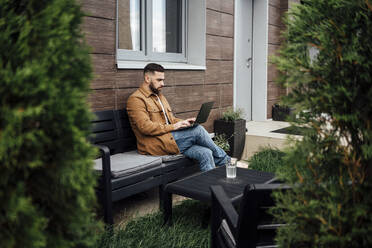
top-left (116, 0), bottom-right (206, 70)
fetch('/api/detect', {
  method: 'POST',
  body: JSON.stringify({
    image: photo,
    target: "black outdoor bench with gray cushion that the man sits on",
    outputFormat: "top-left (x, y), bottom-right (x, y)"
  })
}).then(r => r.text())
top-left (89, 110), bottom-right (199, 225)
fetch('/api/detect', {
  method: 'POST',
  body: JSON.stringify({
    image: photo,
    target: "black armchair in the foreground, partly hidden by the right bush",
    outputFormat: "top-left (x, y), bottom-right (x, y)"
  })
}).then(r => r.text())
top-left (211, 184), bottom-right (289, 248)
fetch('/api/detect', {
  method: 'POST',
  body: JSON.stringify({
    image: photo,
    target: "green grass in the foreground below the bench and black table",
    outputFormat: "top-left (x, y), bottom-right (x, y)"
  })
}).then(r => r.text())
top-left (96, 200), bottom-right (210, 248)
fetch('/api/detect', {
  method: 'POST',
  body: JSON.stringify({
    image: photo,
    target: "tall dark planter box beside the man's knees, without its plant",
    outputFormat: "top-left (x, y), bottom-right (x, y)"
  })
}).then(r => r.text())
top-left (214, 119), bottom-right (246, 159)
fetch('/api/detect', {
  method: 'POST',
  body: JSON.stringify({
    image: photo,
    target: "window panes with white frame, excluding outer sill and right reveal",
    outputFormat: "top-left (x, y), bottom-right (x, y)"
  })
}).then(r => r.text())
top-left (117, 0), bottom-right (187, 62)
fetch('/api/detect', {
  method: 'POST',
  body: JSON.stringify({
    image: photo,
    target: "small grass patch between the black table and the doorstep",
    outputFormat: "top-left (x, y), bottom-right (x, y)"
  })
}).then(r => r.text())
top-left (248, 147), bottom-right (285, 173)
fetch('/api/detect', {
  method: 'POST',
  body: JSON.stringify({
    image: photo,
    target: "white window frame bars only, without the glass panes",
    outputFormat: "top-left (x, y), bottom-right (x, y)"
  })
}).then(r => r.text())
top-left (116, 0), bottom-right (188, 63)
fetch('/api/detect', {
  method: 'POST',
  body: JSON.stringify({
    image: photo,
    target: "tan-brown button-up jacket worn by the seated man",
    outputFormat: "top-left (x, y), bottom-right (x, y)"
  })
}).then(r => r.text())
top-left (127, 84), bottom-right (181, 155)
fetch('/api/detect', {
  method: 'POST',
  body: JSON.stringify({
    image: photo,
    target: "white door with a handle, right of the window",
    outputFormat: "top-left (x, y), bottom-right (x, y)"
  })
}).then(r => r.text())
top-left (234, 0), bottom-right (253, 120)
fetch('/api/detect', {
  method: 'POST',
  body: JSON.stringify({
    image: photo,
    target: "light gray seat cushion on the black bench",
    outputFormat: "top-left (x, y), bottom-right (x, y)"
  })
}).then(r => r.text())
top-left (94, 151), bottom-right (162, 178)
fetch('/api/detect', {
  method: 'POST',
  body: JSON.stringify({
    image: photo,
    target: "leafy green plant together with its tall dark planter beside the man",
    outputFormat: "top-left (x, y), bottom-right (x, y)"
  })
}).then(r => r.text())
top-left (214, 108), bottom-right (246, 159)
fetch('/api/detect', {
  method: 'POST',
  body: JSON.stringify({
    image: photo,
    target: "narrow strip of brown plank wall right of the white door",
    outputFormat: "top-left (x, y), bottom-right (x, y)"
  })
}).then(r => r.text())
top-left (267, 0), bottom-right (288, 119)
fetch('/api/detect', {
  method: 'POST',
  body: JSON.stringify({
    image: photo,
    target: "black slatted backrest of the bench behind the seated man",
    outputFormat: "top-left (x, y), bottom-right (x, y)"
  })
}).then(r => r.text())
top-left (89, 109), bottom-right (137, 155)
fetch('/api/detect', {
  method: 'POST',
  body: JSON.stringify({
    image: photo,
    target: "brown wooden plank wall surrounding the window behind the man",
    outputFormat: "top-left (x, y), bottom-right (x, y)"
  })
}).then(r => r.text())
top-left (80, 0), bottom-right (234, 132)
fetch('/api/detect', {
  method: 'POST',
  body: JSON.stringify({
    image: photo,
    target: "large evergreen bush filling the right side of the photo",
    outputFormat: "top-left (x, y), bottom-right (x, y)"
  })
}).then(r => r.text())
top-left (275, 0), bottom-right (372, 247)
